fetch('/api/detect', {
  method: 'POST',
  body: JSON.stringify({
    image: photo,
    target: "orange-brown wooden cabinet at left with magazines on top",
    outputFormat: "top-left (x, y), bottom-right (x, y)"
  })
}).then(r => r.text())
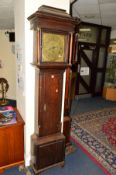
top-left (0, 110), bottom-right (24, 172)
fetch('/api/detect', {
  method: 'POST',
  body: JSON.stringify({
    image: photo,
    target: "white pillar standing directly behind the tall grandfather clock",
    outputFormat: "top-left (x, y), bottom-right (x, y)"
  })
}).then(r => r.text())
top-left (15, 0), bottom-right (69, 165)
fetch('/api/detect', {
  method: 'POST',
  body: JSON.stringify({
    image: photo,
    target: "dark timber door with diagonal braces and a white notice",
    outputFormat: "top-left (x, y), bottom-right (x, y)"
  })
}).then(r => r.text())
top-left (76, 44), bottom-right (95, 95)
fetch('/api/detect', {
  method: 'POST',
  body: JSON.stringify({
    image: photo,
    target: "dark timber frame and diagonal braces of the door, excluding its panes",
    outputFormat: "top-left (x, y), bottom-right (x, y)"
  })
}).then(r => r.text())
top-left (76, 42), bottom-right (98, 96)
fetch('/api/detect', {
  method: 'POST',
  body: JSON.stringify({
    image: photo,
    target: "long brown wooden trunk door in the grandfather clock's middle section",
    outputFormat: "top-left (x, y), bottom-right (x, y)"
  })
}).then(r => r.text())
top-left (38, 70), bottom-right (63, 136)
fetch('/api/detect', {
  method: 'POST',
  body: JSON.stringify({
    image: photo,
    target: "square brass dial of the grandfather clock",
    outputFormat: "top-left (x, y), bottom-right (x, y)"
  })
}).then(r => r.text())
top-left (42, 32), bottom-right (66, 62)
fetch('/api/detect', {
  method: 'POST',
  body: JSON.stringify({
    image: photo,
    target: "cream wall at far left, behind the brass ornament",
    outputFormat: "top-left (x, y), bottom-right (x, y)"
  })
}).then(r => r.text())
top-left (0, 30), bottom-right (16, 100)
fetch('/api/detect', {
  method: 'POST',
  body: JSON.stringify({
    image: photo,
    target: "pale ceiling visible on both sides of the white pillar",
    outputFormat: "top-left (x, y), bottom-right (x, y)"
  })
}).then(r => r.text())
top-left (0, 0), bottom-right (116, 30)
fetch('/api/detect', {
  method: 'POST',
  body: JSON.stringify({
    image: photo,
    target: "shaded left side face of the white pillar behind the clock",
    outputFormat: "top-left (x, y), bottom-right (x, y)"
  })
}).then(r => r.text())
top-left (14, 0), bottom-right (26, 120)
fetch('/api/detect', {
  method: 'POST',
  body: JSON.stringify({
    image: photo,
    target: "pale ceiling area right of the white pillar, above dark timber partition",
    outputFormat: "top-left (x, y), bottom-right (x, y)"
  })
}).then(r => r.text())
top-left (71, 0), bottom-right (116, 30)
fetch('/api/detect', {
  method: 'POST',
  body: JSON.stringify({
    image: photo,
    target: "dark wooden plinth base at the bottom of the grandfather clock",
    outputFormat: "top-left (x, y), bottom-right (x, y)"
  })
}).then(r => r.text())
top-left (31, 133), bottom-right (65, 173)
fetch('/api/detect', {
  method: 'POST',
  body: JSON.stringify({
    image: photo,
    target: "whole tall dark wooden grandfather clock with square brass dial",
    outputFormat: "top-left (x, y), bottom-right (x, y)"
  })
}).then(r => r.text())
top-left (28, 6), bottom-right (78, 173)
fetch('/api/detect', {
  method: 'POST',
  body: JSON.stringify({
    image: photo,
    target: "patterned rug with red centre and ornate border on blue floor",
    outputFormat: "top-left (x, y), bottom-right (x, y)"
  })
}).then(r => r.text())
top-left (71, 108), bottom-right (116, 174)
